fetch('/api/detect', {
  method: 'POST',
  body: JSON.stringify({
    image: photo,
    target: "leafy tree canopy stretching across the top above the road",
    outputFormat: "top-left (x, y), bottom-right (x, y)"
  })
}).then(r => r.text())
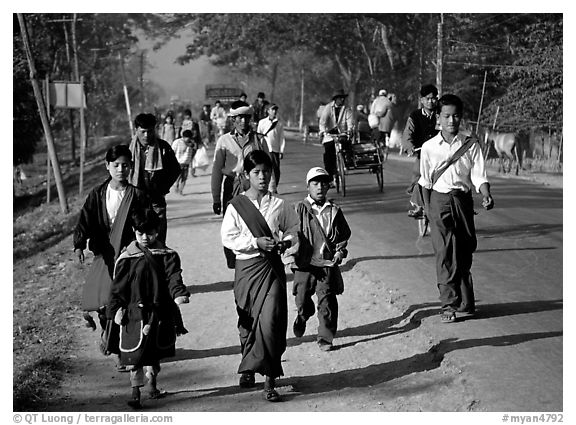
top-left (13, 13), bottom-right (563, 163)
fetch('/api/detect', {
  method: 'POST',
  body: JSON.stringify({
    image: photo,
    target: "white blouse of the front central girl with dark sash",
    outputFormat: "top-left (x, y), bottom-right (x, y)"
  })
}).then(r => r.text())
top-left (220, 192), bottom-right (298, 260)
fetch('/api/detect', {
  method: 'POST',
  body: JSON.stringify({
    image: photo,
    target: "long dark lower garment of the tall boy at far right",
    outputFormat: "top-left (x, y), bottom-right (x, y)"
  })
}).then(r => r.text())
top-left (429, 190), bottom-right (477, 311)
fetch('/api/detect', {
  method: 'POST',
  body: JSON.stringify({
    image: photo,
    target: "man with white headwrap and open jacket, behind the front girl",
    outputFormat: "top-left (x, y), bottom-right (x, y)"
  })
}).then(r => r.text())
top-left (211, 100), bottom-right (268, 269)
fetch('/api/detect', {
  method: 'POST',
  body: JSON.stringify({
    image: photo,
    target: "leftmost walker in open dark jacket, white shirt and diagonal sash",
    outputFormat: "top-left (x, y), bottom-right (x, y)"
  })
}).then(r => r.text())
top-left (73, 145), bottom-right (149, 340)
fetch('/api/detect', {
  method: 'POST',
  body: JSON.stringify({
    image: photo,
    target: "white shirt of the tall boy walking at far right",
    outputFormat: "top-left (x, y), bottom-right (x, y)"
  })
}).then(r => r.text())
top-left (418, 132), bottom-right (488, 193)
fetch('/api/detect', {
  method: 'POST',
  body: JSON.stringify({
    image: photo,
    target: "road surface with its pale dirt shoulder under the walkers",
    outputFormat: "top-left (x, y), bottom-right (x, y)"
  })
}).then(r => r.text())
top-left (54, 133), bottom-right (563, 412)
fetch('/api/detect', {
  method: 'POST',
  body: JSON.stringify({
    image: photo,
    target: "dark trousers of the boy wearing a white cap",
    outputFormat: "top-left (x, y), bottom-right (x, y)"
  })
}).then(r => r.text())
top-left (292, 266), bottom-right (342, 343)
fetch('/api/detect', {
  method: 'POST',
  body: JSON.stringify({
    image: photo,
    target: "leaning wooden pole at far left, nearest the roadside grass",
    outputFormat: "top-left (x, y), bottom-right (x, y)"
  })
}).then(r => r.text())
top-left (17, 13), bottom-right (68, 214)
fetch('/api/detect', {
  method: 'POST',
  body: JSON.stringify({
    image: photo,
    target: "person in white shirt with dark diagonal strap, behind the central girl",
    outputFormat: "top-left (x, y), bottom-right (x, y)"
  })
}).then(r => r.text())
top-left (256, 103), bottom-right (286, 195)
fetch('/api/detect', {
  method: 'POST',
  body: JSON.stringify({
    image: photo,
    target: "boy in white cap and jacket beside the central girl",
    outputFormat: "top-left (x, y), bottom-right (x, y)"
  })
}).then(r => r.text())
top-left (293, 167), bottom-right (351, 351)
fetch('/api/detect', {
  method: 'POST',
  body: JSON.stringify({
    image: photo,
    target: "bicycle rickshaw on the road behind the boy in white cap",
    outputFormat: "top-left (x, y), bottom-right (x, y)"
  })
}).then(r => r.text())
top-left (335, 122), bottom-right (386, 196)
